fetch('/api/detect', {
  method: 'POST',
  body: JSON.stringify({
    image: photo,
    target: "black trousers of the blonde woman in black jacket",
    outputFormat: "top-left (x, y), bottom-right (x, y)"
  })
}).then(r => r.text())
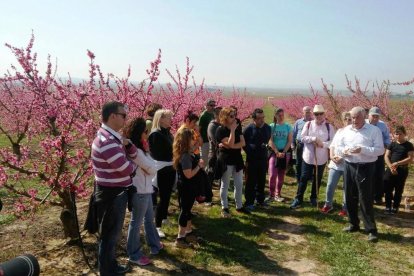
top-left (155, 166), bottom-right (176, 227)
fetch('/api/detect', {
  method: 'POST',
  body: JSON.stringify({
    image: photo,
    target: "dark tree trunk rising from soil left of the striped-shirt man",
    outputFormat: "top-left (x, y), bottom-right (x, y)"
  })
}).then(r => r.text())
top-left (60, 190), bottom-right (79, 240)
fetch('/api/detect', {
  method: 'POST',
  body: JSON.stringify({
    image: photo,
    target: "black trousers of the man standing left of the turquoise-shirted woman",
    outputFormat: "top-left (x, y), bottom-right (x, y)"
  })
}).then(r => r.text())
top-left (244, 159), bottom-right (267, 206)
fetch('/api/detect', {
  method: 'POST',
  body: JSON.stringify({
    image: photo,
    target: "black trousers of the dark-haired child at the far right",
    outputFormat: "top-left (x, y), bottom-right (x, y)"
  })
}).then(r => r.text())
top-left (384, 166), bottom-right (408, 209)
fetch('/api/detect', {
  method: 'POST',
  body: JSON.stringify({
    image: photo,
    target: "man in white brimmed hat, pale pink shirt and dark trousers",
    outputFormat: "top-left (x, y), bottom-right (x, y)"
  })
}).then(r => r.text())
top-left (290, 104), bottom-right (335, 209)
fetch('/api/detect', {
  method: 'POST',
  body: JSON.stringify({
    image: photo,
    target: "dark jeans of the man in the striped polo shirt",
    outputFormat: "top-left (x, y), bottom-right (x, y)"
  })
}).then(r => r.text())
top-left (98, 191), bottom-right (128, 276)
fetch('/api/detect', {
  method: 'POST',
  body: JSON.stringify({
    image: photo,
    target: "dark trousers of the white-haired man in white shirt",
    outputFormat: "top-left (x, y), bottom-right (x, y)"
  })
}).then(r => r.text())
top-left (344, 162), bottom-right (377, 234)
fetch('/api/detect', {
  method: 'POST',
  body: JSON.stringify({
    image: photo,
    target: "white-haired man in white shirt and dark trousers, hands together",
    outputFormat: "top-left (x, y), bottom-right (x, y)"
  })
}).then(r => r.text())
top-left (337, 106), bottom-right (384, 242)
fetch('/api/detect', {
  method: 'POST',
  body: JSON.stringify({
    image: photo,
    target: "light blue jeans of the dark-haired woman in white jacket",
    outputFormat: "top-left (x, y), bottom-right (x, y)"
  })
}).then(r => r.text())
top-left (127, 194), bottom-right (161, 261)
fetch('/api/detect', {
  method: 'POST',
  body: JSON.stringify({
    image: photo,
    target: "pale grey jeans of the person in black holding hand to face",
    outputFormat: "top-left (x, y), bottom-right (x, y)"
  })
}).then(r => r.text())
top-left (220, 165), bottom-right (243, 209)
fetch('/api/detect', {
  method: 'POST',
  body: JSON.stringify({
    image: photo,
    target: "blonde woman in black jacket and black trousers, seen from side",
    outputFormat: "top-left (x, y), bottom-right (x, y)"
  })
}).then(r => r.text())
top-left (148, 109), bottom-right (176, 238)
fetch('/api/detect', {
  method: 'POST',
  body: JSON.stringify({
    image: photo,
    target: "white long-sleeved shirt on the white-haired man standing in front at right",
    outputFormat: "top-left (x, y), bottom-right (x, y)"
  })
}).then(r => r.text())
top-left (336, 123), bottom-right (385, 163)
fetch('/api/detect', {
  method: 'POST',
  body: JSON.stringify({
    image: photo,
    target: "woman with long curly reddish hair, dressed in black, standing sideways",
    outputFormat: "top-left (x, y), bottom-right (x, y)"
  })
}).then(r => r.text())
top-left (173, 128), bottom-right (204, 248)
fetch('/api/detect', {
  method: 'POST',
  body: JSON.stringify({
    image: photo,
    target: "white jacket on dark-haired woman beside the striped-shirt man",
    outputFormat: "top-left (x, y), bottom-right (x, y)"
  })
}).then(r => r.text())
top-left (132, 149), bottom-right (157, 194)
